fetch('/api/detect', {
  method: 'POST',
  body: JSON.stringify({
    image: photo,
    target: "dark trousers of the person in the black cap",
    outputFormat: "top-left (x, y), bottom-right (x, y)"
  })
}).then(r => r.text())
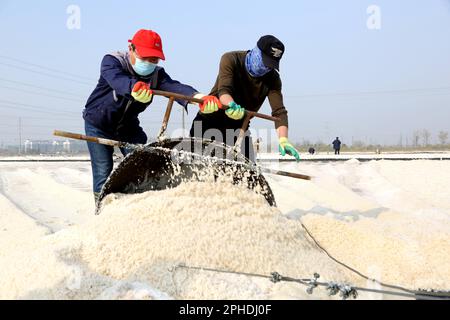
top-left (190, 113), bottom-right (256, 162)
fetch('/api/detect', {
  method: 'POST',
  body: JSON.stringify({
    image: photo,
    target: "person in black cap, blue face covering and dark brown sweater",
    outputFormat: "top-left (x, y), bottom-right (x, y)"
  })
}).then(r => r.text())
top-left (191, 35), bottom-right (300, 161)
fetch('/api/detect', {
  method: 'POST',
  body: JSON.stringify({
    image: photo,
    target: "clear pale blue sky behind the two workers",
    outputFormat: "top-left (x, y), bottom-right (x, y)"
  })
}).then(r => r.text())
top-left (0, 0), bottom-right (450, 143)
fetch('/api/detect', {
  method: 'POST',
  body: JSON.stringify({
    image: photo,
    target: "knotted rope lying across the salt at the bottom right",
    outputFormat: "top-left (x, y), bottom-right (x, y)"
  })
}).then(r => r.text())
top-left (169, 264), bottom-right (450, 300)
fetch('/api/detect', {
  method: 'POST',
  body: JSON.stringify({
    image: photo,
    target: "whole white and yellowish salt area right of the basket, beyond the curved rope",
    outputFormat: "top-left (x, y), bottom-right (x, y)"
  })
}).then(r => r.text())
top-left (269, 160), bottom-right (450, 291)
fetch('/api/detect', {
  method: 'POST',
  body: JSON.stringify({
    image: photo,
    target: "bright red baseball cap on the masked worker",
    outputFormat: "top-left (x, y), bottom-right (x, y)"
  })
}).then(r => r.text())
top-left (128, 29), bottom-right (166, 60)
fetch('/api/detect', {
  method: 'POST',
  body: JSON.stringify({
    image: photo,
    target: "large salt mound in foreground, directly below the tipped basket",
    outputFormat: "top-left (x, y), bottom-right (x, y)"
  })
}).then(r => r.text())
top-left (0, 183), bottom-right (356, 299)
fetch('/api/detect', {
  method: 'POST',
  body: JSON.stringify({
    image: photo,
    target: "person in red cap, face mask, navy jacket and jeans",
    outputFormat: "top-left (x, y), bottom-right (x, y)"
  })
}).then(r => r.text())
top-left (83, 30), bottom-right (221, 201)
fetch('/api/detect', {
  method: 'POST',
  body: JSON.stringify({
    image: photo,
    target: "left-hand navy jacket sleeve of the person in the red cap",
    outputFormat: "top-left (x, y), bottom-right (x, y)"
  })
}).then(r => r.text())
top-left (101, 55), bottom-right (138, 98)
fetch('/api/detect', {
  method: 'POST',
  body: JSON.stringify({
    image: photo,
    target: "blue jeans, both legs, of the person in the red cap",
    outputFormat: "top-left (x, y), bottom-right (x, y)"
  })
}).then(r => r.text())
top-left (85, 121), bottom-right (147, 193)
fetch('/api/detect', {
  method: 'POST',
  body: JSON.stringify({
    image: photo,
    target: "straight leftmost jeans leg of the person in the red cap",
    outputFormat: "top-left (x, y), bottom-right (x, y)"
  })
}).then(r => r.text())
top-left (85, 122), bottom-right (114, 203)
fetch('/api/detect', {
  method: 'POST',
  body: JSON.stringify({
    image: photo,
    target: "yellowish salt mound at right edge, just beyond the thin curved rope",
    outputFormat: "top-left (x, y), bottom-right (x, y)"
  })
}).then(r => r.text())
top-left (303, 211), bottom-right (450, 291)
